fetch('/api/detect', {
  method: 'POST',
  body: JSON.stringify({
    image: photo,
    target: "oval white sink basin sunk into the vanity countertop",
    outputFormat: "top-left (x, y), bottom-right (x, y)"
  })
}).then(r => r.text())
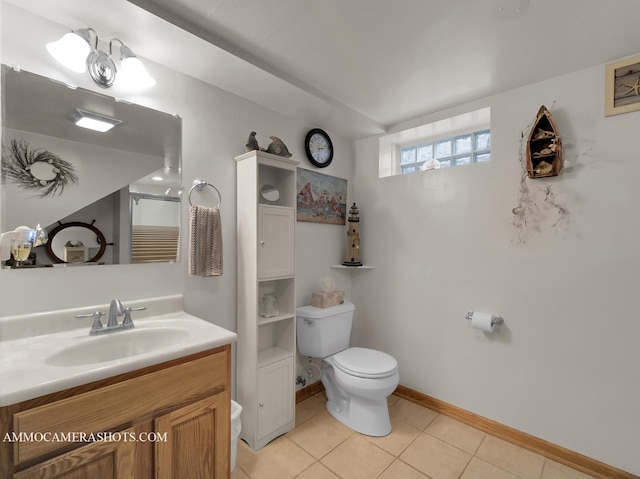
top-left (45, 326), bottom-right (190, 367)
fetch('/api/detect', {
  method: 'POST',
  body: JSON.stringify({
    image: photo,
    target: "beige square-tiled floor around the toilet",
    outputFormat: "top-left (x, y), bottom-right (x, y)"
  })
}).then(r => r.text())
top-left (231, 393), bottom-right (591, 479)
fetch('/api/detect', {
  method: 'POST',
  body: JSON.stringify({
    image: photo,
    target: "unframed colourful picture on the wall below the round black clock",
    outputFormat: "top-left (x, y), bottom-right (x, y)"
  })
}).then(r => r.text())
top-left (297, 168), bottom-right (347, 225)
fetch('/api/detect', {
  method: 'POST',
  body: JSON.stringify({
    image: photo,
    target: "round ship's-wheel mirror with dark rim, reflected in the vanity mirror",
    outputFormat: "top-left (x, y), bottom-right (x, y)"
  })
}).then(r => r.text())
top-left (46, 221), bottom-right (107, 263)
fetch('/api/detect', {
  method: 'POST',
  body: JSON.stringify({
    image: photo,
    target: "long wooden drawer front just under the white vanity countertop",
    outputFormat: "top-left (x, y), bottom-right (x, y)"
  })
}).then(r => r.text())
top-left (13, 348), bottom-right (229, 465)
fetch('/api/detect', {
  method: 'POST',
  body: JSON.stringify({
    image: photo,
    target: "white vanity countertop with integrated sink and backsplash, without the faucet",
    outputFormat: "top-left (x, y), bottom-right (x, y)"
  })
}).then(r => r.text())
top-left (0, 295), bottom-right (236, 407)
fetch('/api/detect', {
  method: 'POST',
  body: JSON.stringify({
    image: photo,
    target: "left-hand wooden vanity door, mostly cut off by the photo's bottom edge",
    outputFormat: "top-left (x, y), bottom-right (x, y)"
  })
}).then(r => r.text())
top-left (13, 430), bottom-right (135, 479)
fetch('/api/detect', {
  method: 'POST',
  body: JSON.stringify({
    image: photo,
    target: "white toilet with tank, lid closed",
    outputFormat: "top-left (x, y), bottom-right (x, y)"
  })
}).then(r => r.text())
top-left (296, 302), bottom-right (400, 436)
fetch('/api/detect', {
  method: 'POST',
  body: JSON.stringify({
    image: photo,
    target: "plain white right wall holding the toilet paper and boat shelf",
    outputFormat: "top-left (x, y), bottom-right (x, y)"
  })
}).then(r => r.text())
top-left (352, 66), bottom-right (640, 474)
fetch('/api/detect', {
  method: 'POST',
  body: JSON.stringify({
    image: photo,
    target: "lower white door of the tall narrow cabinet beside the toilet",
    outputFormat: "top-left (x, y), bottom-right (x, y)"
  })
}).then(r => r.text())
top-left (258, 357), bottom-right (295, 439)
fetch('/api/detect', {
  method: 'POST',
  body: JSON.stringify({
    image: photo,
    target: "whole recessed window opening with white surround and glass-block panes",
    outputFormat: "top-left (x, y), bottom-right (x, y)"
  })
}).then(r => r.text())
top-left (378, 107), bottom-right (491, 178)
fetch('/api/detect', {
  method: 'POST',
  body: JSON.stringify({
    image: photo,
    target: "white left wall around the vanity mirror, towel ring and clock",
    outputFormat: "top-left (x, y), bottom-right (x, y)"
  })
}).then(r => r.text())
top-left (0, 3), bottom-right (353, 344)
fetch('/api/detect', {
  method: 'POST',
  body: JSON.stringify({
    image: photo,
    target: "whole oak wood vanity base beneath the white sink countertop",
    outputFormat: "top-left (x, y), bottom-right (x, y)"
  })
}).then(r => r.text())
top-left (0, 345), bottom-right (231, 479)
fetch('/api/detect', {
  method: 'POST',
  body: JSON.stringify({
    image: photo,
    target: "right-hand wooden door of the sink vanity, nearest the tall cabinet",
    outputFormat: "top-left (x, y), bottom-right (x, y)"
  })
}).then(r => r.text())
top-left (154, 393), bottom-right (231, 479)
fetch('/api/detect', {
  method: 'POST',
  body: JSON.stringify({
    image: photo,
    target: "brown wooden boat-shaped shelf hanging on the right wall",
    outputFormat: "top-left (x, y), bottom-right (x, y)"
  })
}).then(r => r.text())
top-left (527, 105), bottom-right (562, 178)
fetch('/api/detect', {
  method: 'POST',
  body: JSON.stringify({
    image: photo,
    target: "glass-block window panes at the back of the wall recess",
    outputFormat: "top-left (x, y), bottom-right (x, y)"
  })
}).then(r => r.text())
top-left (400, 130), bottom-right (491, 175)
